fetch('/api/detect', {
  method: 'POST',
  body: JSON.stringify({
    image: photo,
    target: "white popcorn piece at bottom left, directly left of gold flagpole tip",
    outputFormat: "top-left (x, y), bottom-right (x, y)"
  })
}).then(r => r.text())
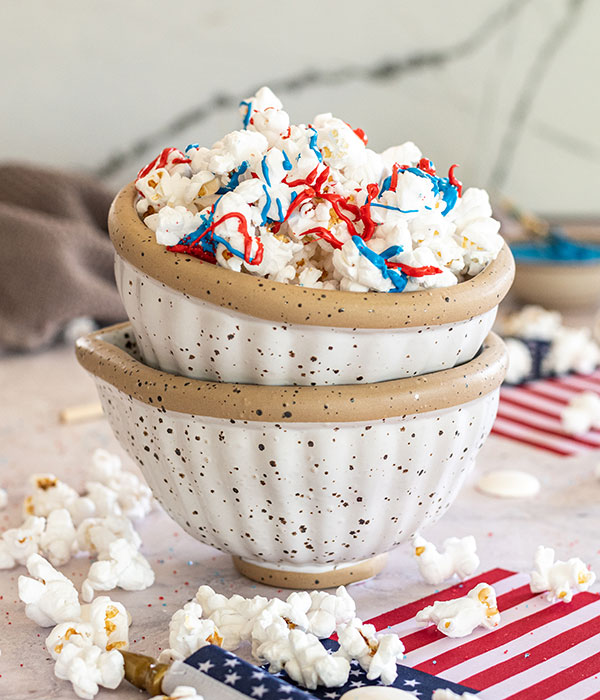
top-left (54, 641), bottom-right (125, 700)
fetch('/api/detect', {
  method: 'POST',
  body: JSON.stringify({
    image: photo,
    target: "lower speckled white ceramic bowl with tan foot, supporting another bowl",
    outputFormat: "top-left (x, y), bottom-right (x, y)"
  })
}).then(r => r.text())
top-left (77, 324), bottom-right (506, 587)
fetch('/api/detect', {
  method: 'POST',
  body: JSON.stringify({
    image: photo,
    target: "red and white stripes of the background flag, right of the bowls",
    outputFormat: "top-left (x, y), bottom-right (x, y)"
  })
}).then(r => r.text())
top-left (492, 370), bottom-right (600, 457)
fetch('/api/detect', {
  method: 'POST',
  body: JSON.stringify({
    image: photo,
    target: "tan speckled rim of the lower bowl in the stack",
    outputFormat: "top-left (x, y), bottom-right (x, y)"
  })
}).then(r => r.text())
top-left (76, 322), bottom-right (508, 423)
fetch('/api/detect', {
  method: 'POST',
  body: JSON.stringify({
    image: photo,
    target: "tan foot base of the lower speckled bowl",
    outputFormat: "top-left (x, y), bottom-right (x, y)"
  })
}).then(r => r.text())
top-left (233, 553), bottom-right (388, 590)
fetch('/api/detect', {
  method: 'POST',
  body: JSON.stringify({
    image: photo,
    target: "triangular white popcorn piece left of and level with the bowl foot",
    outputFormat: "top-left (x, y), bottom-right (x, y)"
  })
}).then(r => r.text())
top-left (81, 539), bottom-right (154, 602)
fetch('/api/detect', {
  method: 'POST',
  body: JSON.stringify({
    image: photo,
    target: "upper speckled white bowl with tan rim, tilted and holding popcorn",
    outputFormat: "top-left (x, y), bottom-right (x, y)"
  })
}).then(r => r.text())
top-left (109, 183), bottom-right (514, 386)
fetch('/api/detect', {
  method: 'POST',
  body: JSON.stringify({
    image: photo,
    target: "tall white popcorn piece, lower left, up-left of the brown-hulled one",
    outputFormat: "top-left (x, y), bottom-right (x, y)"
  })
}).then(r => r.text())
top-left (18, 554), bottom-right (81, 627)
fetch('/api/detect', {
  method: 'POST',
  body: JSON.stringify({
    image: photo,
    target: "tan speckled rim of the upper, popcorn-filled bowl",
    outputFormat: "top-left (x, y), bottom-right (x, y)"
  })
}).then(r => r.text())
top-left (108, 182), bottom-right (515, 329)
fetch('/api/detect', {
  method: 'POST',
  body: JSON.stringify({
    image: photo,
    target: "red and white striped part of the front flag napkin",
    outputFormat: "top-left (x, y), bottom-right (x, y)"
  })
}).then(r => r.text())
top-left (369, 569), bottom-right (600, 700)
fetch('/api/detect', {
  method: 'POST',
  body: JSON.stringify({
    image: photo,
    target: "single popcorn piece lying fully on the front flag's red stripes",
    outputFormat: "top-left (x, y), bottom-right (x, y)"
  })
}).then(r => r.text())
top-left (416, 583), bottom-right (500, 638)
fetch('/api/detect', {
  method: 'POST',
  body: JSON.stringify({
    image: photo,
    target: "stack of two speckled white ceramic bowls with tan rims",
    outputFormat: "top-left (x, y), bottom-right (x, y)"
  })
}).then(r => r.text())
top-left (77, 185), bottom-right (514, 588)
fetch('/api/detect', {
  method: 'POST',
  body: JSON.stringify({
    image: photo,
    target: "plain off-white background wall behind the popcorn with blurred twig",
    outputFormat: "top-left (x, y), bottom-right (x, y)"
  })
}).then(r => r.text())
top-left (0, 0), bottom-right (600, 215)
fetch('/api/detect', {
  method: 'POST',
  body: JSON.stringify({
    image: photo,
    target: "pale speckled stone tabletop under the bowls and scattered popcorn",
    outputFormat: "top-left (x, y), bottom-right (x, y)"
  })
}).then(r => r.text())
top-left (0, 348), bottom-right (600, 700)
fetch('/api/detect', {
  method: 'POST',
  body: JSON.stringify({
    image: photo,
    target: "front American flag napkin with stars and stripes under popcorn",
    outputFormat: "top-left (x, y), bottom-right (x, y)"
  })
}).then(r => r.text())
top-left (165, 569), bottom-right (600, 700)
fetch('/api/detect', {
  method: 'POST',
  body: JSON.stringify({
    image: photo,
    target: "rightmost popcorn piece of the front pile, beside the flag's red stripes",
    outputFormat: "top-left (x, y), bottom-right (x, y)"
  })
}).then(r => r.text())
top-left (336, 618), bottom-right (404, 685)
